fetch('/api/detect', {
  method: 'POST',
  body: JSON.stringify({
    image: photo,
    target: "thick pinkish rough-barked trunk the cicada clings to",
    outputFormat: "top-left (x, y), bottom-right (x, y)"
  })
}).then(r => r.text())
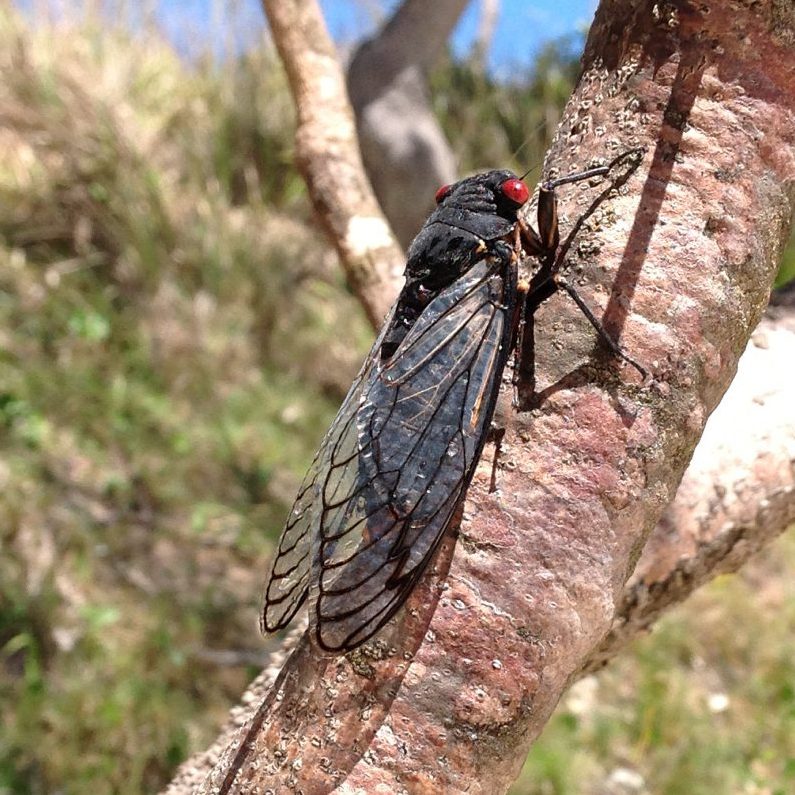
top-left (165, 0), bottom-right (795, 793)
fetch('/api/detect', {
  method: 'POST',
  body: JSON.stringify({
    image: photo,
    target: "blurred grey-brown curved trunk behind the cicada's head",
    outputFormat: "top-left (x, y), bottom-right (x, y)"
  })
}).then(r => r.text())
top-left (348, 0), bottom-right (469, 247)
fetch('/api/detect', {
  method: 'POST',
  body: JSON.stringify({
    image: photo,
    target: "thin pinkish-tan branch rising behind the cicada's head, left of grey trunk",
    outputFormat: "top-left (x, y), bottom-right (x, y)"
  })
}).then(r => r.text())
top-left (263, 0), bottom-right (404, 327)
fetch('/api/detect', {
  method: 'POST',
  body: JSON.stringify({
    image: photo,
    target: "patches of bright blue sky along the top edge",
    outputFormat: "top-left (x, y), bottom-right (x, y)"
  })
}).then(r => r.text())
top-left (16, 0), bottom-right (597, 74)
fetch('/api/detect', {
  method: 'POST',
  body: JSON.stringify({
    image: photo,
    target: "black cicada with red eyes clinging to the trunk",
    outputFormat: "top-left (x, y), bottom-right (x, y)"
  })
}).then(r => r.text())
top-left (262, 149), bottom-right (638, 653)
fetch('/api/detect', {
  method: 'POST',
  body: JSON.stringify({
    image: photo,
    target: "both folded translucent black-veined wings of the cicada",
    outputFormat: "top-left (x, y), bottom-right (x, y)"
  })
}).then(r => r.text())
top-left (264, 256), bottom-right (516, 651)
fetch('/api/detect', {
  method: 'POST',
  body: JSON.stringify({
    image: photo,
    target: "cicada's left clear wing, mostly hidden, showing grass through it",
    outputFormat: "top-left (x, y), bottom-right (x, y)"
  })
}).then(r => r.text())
top-left (262, 318), bottom-right (390, 632)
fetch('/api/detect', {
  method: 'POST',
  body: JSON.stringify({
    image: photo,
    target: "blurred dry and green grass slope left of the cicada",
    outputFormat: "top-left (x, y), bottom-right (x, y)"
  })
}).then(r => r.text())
top-left (0, 11), bottom-right (370, 793)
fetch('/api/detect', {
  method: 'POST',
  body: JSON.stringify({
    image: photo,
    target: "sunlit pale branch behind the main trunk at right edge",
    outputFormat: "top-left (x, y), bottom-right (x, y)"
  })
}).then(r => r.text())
top-left (585, 310), bottom-right (795, 672)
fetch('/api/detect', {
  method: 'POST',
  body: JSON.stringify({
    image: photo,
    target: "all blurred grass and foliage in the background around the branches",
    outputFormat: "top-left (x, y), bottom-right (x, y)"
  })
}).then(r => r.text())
top-left (0, 4), bottom-right (795, 795)
